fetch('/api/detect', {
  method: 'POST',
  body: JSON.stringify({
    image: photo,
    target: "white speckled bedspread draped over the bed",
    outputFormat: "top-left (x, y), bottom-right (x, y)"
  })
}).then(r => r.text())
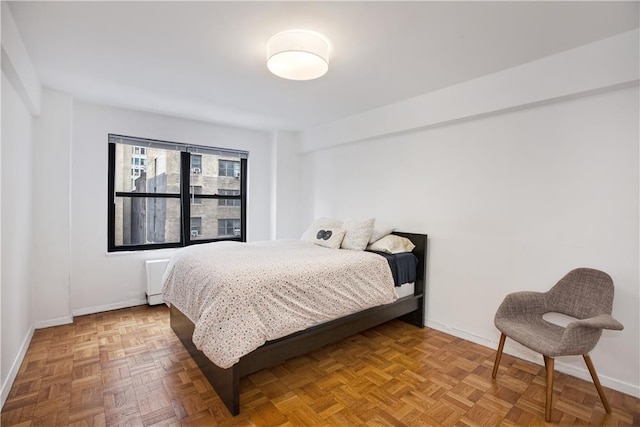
top-left (163, 240), bottom-right (398, 368)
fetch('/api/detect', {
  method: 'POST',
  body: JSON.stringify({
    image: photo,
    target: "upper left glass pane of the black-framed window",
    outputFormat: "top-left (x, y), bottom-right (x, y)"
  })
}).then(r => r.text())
top-left (115, 144), bottom-right (180, 194)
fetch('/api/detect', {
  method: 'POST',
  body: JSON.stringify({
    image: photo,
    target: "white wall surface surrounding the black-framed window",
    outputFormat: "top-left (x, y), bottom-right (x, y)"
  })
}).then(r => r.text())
top-left (70, 101), bottom-right (272, 315)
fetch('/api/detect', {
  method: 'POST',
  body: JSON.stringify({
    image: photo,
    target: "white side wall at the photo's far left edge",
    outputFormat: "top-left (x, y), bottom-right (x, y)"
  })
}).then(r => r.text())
top-left (0, 2), bottom-right (41, 406)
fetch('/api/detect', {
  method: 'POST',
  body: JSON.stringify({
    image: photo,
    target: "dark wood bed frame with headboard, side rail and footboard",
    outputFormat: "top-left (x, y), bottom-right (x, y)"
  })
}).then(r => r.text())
top-left (170, 232), bottom-right (427, 415)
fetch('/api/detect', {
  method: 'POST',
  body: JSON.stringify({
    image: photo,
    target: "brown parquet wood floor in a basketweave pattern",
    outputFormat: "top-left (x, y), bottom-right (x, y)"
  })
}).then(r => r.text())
top-left (1, 306), bottom-right (640, 427)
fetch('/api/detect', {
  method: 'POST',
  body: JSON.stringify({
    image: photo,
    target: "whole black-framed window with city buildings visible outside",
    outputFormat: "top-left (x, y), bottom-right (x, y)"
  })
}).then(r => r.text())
top-left (107, 135), bottom-right (248, 252)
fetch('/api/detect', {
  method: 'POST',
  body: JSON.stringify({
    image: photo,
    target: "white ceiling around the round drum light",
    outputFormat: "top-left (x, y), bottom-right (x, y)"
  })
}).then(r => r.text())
top-left (10, 1), bottom-right (639, 130)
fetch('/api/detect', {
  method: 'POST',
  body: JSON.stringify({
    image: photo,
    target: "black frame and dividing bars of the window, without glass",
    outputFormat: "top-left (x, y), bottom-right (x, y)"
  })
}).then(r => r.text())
top-left (107, 134), bottom-right (249, 252)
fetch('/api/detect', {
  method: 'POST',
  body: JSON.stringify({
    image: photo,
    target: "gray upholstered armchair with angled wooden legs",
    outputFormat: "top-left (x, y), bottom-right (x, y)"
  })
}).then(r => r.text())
top-left (492, 268), bottom-right (623, 422)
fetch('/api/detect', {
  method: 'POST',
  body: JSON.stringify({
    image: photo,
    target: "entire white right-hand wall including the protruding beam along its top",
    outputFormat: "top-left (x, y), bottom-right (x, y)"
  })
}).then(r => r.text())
top-left (300, 30), bottom-right (640, 397)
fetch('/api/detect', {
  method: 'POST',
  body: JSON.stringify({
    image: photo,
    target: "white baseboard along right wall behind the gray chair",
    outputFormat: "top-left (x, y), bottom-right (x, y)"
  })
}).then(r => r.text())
top-left (426, 320), bottom-right (640, 398)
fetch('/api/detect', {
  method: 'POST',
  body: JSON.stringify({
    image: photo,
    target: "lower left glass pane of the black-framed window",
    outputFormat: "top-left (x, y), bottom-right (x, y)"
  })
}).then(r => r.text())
top-left (115, 197), bottom-right (181, 246)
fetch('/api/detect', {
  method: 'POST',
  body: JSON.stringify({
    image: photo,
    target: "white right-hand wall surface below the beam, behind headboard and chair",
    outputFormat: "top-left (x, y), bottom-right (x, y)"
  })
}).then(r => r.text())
top-left (301, 87), bottom-right (640, 395)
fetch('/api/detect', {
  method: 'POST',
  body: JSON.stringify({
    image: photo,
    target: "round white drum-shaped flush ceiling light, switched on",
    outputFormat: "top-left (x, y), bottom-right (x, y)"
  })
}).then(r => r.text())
top-left (267, 30), bottom-right (329, 80)
